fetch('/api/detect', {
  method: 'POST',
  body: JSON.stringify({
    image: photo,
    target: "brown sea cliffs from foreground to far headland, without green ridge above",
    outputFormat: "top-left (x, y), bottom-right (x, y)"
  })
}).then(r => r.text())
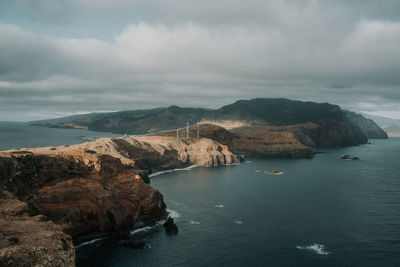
top-left (0, 117), bottom-right (376, 266)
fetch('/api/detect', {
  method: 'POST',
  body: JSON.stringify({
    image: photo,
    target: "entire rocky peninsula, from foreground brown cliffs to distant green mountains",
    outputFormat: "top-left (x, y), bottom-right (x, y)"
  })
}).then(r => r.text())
top-left (0, 99), bottom-right (388, 266)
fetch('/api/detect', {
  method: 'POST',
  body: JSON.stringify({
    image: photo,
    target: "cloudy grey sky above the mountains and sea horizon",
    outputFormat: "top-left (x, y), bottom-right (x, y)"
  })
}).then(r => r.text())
top-left (0, 0), bottom-right (400, 121)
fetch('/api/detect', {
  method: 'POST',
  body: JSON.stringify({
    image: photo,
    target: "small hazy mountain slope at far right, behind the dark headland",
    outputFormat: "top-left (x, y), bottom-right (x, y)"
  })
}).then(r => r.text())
top-left (345, 110), bottom-right (388, 139)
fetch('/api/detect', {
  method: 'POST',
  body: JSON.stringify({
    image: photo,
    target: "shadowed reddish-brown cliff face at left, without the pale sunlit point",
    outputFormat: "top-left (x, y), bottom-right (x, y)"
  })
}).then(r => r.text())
top-left (0, 151), bottom-right (165, 237)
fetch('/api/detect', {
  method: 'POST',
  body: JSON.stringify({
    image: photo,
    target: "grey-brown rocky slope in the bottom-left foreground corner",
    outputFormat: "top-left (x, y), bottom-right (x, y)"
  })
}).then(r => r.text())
top-left (0, 190), bottom-right (75, 267)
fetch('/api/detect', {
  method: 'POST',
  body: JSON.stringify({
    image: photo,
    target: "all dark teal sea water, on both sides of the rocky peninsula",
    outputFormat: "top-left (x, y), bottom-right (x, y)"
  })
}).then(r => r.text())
top-left (0, 123), bottom-right (400, 266)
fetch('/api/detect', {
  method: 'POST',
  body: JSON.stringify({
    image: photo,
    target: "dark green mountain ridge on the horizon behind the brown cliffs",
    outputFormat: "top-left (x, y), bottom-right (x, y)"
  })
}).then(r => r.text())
top-left (30, 98), bottom-right (388, 146)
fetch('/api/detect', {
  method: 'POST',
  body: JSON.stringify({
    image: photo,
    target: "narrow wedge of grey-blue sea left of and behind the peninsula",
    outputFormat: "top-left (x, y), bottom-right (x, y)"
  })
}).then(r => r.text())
top-left (0, 121), bottom-right (121, 151)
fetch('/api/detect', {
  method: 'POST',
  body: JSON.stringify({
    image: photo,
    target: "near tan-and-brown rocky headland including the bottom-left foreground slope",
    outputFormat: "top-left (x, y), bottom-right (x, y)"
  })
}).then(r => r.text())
top-left (0, 136), bottom-right (237, 266)
